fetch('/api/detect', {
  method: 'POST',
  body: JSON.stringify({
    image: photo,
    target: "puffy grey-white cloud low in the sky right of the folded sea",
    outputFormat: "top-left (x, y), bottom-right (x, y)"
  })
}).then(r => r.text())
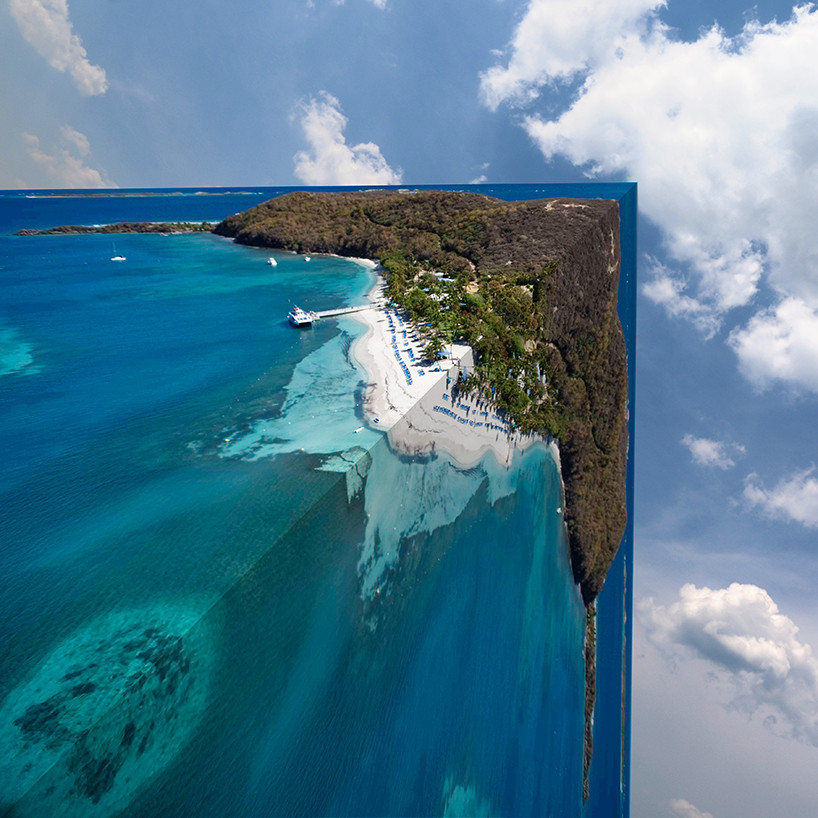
top-left (638, 583), bottom-right (818, 744)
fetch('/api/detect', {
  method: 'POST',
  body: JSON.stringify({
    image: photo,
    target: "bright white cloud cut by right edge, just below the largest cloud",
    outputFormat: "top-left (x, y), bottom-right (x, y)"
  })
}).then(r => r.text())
top-left (728, 296), bottom-right (818, 392)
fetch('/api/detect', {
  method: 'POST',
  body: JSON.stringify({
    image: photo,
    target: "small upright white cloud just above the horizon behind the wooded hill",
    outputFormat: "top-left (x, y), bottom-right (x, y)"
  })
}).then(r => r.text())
top-left (293, 91), bottom-right (401, 185)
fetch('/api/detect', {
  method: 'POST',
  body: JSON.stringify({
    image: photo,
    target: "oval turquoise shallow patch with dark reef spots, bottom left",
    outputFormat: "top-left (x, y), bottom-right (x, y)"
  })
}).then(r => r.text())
top-left (0, 604), bottom-right (215, 816)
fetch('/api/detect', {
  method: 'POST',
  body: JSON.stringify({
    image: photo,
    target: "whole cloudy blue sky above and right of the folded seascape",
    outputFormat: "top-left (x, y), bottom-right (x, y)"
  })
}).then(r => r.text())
top-left (0, 0), bottom-right (818, 818)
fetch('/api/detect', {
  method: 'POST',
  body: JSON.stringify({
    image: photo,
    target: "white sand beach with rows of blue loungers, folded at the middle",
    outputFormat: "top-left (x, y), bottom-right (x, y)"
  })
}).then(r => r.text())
top-left (350, 274), bottom-right (542, 466)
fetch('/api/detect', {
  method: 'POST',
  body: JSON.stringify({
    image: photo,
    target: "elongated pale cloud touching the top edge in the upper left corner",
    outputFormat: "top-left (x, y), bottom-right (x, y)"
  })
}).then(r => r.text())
top-left (9, 0), bottom-right (108, 96)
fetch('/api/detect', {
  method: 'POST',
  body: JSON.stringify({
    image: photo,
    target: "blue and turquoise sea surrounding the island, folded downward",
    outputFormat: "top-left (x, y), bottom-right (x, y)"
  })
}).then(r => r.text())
top-left (0, 185), bottom-right (635, 818)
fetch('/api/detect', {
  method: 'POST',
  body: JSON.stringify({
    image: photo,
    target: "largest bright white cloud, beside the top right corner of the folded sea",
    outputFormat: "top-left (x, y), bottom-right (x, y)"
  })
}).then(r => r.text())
top-left (526, 9), bottom-right (818, 313)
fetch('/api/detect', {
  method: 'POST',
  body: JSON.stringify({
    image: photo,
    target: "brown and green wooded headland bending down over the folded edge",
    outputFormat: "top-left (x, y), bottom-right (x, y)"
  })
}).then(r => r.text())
top-left (215, 191), bottom-right (628, 604)
